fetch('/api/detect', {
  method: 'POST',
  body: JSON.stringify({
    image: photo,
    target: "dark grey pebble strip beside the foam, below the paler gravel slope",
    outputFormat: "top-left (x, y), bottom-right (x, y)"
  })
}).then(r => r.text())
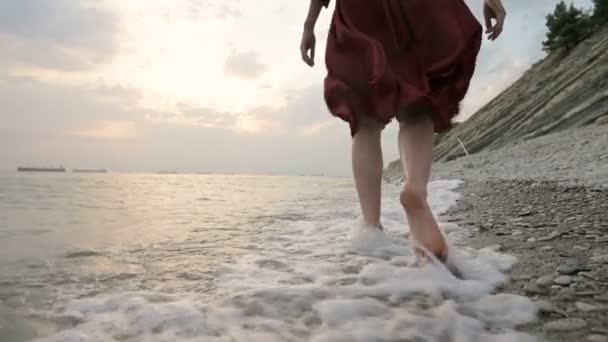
top-left (442, 179), bottom-right (608, 342)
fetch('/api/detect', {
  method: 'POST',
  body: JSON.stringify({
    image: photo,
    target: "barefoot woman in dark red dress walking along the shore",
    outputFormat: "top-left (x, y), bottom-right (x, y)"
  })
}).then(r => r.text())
top-left (300, 0), bottom-right (506, 262)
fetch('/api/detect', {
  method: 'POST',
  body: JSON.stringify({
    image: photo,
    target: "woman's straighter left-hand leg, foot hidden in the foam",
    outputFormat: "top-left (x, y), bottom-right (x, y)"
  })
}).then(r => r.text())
top-left (352, 118), bottom-right (384, 228)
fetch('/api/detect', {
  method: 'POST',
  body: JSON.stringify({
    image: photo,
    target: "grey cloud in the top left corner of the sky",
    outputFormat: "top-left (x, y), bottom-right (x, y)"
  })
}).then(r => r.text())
top-left (0, 0), bottom-right (118, 70)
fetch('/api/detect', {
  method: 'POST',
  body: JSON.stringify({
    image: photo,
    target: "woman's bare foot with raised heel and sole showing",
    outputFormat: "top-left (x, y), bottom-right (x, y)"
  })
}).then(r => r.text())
top-left (400, 186), bottom-right (447, 261)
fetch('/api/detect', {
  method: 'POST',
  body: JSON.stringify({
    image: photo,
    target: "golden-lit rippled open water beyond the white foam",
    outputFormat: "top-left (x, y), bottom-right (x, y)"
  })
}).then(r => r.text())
top-left (0, 173), bottom-right (356, 340)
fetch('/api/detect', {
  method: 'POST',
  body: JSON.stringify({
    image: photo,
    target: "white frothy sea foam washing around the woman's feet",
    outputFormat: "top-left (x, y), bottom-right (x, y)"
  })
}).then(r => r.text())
top-left (34, 181), bottom-right (536, 342)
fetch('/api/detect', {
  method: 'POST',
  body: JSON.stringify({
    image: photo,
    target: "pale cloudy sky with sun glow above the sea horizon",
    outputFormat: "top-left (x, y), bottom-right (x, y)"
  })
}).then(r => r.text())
top-left (0, 0), bottom-right (591, 176)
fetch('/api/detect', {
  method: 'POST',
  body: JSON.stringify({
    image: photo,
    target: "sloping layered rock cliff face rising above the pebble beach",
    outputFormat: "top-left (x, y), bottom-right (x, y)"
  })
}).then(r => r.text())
top-left (430, 27), bottom-right (608, 162)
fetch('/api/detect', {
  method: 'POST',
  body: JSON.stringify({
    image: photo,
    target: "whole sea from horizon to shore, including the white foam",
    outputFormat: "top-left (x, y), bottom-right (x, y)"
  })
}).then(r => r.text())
top-left (0, 173), bottom-right (536, 342)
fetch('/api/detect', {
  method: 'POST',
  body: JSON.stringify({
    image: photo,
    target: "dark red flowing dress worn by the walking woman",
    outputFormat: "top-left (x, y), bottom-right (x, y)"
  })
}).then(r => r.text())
top-left (324, 0), bottom-right (482, 135)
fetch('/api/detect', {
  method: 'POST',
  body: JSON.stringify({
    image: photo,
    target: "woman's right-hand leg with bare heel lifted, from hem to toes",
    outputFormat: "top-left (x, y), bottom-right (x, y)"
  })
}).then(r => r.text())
top-left (399, 113), bottom-right (446, 259)
